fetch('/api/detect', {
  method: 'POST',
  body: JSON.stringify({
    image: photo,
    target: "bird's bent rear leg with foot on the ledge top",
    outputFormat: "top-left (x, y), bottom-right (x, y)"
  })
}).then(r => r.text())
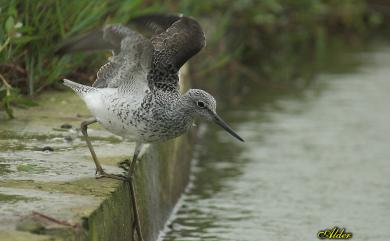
top-left (81, 118), bottom-right (127, 181)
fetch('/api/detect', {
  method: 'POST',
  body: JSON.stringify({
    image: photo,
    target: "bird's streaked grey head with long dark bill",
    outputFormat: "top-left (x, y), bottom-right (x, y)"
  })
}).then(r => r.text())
top-left (185, 89), bottom-right (244, 141)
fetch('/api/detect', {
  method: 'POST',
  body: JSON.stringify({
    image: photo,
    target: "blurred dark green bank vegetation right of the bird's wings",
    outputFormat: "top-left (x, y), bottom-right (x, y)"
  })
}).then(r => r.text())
top-left (185, 0), bottom-right (382, 86)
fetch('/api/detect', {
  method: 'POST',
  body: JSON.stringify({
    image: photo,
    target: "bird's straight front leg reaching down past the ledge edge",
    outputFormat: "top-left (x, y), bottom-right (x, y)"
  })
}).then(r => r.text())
top-left (128, 142), bottom-right (144, 241)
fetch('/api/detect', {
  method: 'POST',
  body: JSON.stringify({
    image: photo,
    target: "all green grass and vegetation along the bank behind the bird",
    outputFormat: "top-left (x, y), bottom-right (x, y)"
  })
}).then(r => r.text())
top-left (0, 0), bottom-right (381, 117)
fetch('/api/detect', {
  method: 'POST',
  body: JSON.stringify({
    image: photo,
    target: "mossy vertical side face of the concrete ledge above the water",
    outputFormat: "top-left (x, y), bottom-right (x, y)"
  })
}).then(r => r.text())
top-left (87, 133), bottom-right (195, 241)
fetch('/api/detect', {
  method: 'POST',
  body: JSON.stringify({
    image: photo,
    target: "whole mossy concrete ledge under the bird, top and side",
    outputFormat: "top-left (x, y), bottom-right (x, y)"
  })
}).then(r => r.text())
top-left (0, 68), bottom-right (195, 241)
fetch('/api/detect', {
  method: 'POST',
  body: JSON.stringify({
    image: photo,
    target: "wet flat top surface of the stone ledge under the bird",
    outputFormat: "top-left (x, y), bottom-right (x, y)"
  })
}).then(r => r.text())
top-left (0, 92), bottom-right (134, 240)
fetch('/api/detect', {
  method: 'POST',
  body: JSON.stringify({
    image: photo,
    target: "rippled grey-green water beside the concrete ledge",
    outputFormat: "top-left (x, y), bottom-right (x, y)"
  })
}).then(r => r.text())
top-left (163, 42), bottom-right (390, 241)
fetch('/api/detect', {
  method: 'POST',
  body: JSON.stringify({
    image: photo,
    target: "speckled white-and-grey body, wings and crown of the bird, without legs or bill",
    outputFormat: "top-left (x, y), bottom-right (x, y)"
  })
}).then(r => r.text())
top-left (64, 17), bottom-right (216, 143)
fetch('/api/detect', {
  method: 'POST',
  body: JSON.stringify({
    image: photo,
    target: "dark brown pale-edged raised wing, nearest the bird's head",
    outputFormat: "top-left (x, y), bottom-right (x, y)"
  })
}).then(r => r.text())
top-left (148, 17), bottom-right (205, 91)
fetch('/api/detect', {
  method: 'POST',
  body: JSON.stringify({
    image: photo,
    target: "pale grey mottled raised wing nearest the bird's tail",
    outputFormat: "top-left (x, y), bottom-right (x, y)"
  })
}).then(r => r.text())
top-left (92, 25), bottom-right (153, 91)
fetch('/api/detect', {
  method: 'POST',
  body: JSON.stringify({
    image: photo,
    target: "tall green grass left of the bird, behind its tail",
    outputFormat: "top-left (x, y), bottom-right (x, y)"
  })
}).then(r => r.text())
top-left (0, 0), bottom-right (161, 118)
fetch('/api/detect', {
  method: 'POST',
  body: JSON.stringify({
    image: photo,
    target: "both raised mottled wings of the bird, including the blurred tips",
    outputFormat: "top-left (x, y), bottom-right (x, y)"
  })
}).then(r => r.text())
top-left (56, 14), bottom-right (205, 90)
